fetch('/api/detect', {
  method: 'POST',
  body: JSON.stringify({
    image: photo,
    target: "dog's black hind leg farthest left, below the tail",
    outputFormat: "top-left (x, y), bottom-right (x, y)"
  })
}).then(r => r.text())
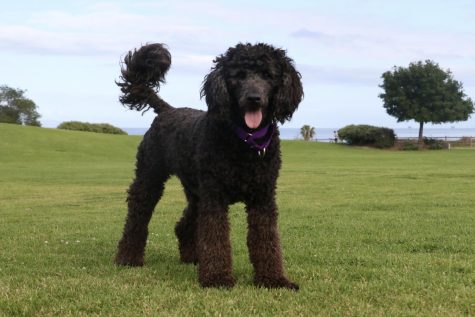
top-left (115, 152), bottom-right (169, 266)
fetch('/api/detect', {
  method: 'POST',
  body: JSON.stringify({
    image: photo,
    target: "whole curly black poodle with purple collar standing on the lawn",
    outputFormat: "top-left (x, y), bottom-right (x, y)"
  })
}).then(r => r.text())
top-left (115, 44), bottom-right (303, 289)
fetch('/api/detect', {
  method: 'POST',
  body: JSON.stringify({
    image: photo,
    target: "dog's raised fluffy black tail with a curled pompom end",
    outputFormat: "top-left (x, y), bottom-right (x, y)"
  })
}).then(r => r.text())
top-left (116, 43), bottom-right (172, 114)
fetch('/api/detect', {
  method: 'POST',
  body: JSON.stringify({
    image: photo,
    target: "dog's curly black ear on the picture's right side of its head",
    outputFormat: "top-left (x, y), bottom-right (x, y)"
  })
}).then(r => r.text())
top-left (274, 55), bottom-right (303, 123)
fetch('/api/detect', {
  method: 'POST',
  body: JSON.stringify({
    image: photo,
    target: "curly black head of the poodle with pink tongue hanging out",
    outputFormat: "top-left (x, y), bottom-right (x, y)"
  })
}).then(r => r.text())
top-left (201, 44), bottom-right (303, 130)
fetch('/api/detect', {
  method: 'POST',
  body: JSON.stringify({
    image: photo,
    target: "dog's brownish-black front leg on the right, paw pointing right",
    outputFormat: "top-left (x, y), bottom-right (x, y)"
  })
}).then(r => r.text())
top-left (247, 202), bottom-right (299, 290)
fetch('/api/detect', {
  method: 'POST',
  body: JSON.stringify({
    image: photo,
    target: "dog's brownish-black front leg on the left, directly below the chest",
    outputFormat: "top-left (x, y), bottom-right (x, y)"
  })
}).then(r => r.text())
top-left (197, 201), bottom-right (235, 287)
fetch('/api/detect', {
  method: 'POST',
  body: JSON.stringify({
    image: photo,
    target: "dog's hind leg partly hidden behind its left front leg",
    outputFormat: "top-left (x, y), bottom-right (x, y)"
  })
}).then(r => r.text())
top-left (175, 188), bottom-right (198, 264)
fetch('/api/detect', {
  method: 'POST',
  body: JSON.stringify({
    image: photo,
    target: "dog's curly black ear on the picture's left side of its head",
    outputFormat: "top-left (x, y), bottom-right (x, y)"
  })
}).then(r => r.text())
top-left (200, 65), bottom-right (231, 116)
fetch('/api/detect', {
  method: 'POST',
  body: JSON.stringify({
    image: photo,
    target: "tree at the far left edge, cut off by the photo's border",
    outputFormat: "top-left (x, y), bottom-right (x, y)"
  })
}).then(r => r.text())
top-left (0, 86), bottom-right (41, 126)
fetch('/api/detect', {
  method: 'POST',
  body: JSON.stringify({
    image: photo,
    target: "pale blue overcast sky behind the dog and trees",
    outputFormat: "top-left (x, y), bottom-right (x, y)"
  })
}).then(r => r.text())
top-left (0, 0), bottom-right (475, 128)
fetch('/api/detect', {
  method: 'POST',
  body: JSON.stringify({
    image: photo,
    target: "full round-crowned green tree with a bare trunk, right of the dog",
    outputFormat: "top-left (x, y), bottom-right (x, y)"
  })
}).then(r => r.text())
top-left (379, 60), bottom-right (474, 146)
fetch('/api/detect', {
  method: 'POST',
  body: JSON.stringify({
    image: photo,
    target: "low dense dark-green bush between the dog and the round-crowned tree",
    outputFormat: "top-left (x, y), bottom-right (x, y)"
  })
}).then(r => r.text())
top-left (338, 125), bottom-right (396, 148)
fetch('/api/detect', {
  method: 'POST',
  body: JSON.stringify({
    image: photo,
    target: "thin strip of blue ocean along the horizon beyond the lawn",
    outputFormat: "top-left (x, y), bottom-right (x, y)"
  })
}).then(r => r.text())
top-left (122, 127), bottom-right (475, 142)
